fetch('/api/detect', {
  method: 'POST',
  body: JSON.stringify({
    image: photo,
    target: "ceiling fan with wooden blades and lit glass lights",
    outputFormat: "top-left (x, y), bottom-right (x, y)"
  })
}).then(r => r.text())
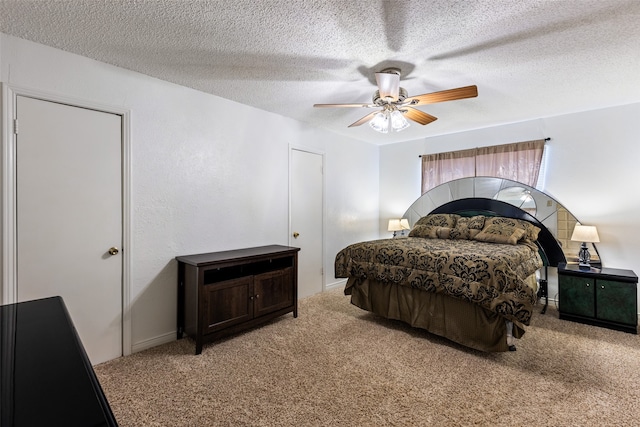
top-left (313, 68), bottom-right (478, 133)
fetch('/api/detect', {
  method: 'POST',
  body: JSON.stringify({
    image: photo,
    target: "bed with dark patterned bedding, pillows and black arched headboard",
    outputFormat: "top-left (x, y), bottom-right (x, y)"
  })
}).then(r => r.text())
top-left (335, 198), bottom-right (565, 352)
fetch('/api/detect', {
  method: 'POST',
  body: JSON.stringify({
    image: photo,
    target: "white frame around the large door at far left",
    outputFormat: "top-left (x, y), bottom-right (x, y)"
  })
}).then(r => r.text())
top-left (0, 83), bottom-right (132, 356)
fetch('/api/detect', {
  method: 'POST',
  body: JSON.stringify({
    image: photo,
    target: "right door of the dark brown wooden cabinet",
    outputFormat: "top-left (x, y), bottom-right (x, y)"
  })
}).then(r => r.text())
top-left (254, 267), bottom-right (295, 317)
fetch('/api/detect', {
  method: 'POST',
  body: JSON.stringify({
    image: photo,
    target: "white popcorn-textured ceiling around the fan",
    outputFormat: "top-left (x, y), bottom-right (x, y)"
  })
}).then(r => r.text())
top-left (0, 0), bottom-right (640, 144)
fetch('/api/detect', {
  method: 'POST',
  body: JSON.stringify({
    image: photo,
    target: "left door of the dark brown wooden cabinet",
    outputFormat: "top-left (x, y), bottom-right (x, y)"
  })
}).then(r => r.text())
top-left (202, 276), bottom-right (253, 334)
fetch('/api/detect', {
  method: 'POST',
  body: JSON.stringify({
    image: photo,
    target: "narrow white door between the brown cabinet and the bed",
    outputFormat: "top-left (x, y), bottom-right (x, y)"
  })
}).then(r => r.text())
top-left (290, 149), bottom-right (324, 298)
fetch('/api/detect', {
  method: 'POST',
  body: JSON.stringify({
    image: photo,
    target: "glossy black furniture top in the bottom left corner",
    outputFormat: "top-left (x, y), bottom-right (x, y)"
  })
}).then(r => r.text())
top-left (0, 297), bottom-right (118, 427)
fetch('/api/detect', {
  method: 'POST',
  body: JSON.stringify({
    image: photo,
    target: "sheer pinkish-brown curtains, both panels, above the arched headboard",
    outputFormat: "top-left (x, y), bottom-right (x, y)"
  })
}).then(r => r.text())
top-left (422, 139), bottom-right (545, 194)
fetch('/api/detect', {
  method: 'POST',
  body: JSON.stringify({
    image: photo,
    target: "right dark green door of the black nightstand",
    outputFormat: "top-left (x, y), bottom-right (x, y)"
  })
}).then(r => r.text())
top-left (596, 279), bottom-right (637, 325)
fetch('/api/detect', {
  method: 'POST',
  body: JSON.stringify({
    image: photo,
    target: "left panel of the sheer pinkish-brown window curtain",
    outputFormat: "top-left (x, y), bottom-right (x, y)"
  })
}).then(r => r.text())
top-left (422, 148), bottom-right (476, 194)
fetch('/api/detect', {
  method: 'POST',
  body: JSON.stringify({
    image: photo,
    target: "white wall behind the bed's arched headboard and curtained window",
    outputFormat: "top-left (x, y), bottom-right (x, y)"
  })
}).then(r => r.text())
top-left (380, 103), bottom-right (640, 310)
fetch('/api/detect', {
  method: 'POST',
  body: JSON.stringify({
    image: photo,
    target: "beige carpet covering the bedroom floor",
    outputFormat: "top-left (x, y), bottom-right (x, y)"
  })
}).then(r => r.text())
top-left (95, 290), bottom-right (640, 426)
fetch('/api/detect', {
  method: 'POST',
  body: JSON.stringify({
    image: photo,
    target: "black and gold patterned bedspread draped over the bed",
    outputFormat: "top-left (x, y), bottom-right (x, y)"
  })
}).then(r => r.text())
top-left (335, 237), bottom-right (542, 325)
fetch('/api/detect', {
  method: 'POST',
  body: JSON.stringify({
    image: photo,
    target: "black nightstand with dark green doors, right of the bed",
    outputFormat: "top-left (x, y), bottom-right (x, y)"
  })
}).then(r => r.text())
top-left (558, 264), bottom-right (638, 334)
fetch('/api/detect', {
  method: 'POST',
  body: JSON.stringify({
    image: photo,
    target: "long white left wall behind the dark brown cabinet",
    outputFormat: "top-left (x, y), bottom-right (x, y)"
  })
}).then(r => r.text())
top-left (0, 34), bottom-right (379, 351)
